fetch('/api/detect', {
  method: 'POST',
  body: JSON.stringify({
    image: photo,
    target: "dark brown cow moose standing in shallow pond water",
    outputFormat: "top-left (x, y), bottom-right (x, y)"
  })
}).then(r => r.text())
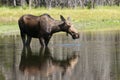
top-left (18, 14), bottom-right (79, 46)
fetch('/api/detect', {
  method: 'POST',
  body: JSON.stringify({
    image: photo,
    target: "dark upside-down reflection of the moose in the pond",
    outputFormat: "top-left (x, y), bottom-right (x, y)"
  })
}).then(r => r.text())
top-left (19, 47), bottom-right (79, 77)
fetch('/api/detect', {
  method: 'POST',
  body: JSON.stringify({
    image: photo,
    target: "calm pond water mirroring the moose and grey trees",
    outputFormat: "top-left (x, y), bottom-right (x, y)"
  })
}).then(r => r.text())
top-left (0, 31), bottom-right (120, 80)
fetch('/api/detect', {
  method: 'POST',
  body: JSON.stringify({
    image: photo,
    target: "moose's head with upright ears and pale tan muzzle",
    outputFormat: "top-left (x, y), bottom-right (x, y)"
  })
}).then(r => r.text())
top-left (60, 15), bottom-right (79, 39)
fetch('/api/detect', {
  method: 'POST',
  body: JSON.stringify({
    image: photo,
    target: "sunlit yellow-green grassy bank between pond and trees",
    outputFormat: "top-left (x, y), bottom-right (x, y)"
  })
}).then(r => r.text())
top-left (0, 6), bottom-right (120, 32)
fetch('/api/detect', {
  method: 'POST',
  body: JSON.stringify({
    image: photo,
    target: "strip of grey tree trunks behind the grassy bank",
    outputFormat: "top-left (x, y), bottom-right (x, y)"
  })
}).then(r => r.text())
top-left (0, 0), bottom-right (120, 9)
